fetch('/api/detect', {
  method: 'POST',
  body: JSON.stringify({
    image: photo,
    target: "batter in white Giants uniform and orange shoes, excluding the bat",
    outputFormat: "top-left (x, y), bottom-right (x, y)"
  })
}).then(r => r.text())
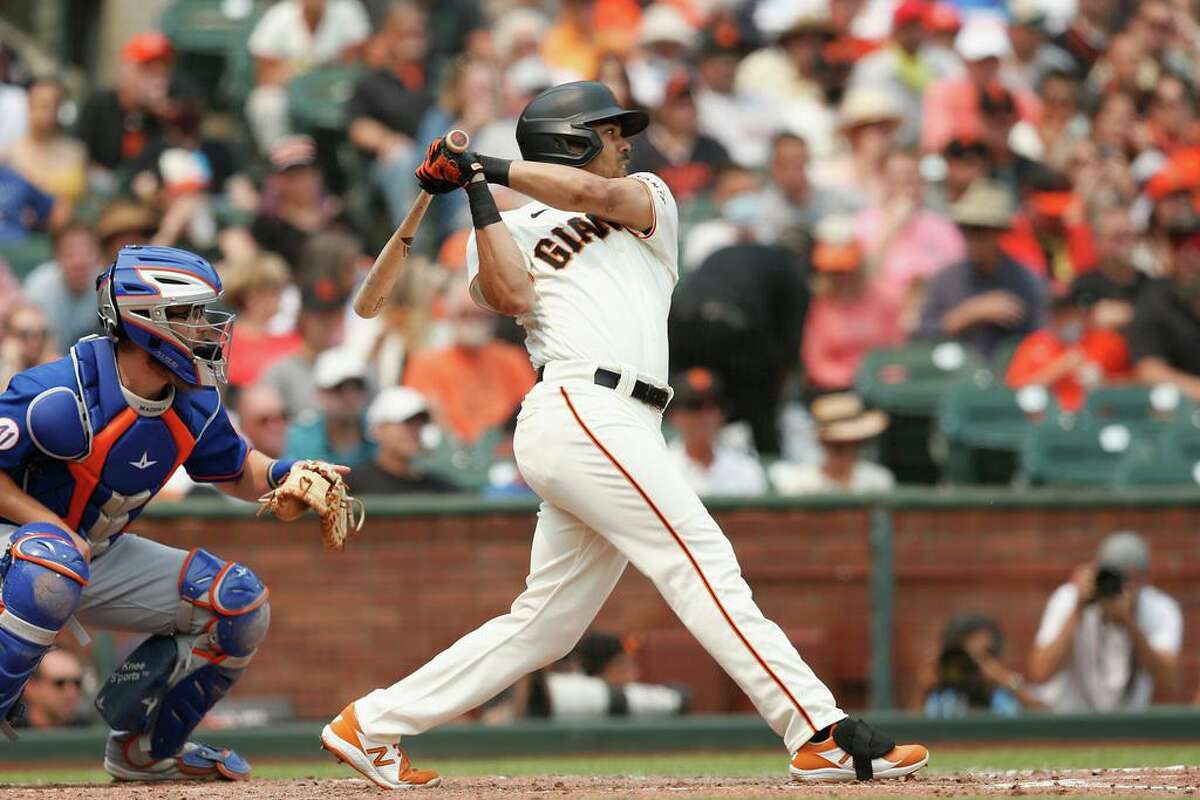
top-left (322, 82), bottom-right (929, 788)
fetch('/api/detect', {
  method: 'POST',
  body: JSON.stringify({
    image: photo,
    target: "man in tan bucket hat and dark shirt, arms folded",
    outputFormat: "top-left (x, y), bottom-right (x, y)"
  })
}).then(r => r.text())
top-left (917, 181), bottom-right (1045, 357)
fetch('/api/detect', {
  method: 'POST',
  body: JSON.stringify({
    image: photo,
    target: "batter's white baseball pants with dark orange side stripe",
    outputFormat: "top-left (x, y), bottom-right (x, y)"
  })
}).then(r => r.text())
top-left (355, 361), bottom-right (846, 752)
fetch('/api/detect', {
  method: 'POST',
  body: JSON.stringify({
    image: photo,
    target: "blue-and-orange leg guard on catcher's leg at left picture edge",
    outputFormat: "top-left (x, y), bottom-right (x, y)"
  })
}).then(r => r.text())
top-left (0, 523), bottom-right (91, 720)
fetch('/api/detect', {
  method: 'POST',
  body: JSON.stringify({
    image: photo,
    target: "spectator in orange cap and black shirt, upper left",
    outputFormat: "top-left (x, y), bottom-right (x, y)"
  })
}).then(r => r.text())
top-left (76, 32), bottom-right (174, 172)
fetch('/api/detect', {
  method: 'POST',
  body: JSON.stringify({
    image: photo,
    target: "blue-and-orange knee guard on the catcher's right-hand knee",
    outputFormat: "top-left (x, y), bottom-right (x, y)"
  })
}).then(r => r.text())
top-left (179, 548), bottom-right (271, 663)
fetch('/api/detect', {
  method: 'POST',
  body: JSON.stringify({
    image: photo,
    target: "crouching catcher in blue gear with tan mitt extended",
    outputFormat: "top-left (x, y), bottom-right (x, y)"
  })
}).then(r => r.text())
top-left (0, 246), bottom-right (350, 781)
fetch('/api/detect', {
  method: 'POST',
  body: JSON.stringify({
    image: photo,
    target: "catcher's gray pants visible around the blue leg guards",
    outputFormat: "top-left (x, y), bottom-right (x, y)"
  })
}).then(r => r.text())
top-left (0, 525), bottom-right (214, 652)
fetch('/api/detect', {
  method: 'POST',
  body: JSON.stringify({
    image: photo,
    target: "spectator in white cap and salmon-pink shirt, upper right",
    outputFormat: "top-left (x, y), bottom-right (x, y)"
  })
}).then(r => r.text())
top-left (920, 17), bottom-right (1038, 152)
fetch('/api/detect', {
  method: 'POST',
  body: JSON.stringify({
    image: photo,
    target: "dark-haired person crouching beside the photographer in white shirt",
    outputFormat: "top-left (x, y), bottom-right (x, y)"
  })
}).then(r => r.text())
top-left (914, 613), bottom-right (1042, 718)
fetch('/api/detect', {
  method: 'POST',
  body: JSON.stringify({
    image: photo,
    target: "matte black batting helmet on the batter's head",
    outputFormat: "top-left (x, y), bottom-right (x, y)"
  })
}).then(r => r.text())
top-left (517, 80), bottom-right (649, 167)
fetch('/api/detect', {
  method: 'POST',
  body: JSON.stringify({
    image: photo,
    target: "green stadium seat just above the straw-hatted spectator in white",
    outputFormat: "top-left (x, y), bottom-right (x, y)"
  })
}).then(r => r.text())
top-left (854, 342), bottom-right (983, 416)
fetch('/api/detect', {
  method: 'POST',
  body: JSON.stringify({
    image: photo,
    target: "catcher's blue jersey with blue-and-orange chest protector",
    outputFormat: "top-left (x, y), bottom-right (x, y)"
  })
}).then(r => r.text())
top-left (0, 337), bottom-right (250, 547)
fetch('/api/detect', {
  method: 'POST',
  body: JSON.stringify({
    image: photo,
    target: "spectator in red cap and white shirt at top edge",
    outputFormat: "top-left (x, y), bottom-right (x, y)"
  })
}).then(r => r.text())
top-left (850, 0), bottom-right (961, 148)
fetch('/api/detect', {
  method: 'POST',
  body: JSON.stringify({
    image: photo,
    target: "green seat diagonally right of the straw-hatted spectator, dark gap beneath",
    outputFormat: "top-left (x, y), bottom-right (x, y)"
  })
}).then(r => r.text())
top-left (937, 372), bottom-right (1058, 483)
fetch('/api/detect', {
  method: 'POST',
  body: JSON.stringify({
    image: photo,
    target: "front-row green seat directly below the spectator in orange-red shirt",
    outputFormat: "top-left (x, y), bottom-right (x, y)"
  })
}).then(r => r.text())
top-left (1021, 417), bottom-right (1147, 486)
